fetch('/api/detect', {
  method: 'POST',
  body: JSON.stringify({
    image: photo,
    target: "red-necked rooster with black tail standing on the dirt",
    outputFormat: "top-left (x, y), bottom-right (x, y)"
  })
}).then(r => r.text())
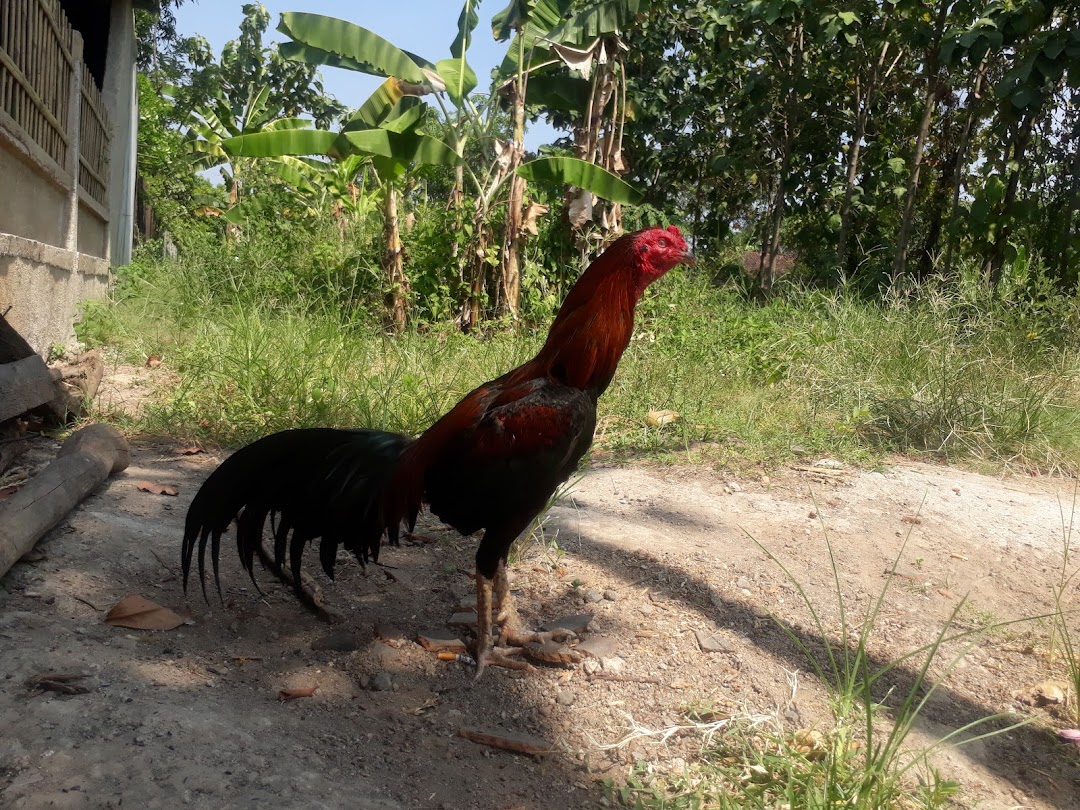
top-left (181, 226), bottom-right (693, 677)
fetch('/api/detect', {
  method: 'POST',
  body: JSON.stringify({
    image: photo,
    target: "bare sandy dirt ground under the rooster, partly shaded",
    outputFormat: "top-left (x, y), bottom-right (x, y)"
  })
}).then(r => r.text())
top-left (0, 421), bottom-right (1080, 810)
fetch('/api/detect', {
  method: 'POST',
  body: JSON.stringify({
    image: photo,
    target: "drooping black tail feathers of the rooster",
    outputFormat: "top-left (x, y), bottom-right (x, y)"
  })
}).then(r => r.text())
top-left (181, 428), bottom-right (411, 596)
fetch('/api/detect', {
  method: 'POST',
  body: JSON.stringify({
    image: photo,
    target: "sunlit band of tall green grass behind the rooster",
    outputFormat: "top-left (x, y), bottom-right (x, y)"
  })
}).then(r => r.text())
top-left (82, 247), bottom-right (1080, 470)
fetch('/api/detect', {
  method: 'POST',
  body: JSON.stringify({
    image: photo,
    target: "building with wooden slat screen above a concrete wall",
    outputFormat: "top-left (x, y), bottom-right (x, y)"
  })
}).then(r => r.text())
top-left (0, 0), bottom-right (158, 354)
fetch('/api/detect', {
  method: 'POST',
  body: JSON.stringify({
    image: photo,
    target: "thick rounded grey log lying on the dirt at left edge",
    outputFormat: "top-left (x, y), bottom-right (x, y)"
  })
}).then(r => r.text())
top-left (0, 424), bottom-right (131, 577)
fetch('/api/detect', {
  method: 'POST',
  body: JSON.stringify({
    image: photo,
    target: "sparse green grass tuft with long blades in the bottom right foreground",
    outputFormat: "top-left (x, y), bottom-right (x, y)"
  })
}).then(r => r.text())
top-left (608, 516), bottom-right (1025, 810)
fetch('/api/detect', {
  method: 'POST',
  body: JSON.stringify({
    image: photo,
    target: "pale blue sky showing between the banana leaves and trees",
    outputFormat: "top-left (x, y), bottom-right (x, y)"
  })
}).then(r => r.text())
top-left (176, 0), bottom-right (558, 148)
